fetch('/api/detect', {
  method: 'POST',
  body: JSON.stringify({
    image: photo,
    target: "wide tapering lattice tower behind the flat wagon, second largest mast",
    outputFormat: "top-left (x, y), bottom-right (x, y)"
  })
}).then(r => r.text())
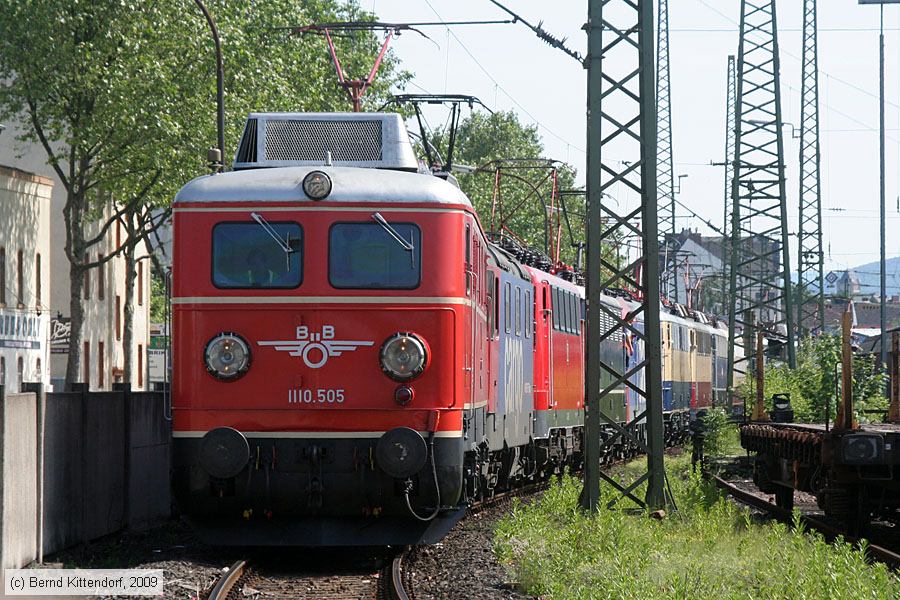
top-left (728, 0), bottom-right (796, 390)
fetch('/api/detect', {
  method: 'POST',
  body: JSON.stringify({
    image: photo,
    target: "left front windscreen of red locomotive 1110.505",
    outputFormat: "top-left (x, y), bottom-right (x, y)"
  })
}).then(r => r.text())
top-left (212, 221), bottom-right (303, 289)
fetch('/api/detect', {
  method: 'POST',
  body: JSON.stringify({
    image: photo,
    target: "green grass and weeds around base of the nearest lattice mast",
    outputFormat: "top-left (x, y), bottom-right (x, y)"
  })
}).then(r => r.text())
top-left (494, 456), bottom-right (900, 600)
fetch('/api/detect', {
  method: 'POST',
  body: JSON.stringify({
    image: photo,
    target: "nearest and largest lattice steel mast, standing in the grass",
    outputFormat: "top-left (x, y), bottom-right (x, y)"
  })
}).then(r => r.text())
top-left (581, 0), bottom-right (666, 510)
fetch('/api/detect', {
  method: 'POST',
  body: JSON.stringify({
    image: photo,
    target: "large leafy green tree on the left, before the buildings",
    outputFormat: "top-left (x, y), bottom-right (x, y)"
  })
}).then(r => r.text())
top-left (0, 0), bottom-right (405, 384)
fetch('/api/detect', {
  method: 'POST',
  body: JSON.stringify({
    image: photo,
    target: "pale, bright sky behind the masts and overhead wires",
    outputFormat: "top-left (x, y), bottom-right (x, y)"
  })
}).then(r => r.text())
top-left (370, 0), bottom-right (900, 272)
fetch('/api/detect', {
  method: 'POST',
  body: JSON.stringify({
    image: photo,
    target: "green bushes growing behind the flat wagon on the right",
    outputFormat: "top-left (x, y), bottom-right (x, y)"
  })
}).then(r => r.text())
top-left (737, 334), bottom-right (887, 423)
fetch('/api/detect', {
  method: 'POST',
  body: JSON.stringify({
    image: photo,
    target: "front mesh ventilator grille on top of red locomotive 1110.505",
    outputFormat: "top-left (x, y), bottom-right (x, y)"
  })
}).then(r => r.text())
top-left (264, 119), bottom-right (381, 162)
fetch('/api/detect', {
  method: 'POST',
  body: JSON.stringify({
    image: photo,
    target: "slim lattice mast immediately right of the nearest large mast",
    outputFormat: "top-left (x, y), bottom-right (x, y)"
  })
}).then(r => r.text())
top-left (656, 0), bottom-right (678, 302)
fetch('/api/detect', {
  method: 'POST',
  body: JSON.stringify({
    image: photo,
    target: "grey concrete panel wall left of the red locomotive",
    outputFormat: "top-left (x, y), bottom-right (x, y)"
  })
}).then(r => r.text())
top-left (0, 388), bottom-right (170, 568)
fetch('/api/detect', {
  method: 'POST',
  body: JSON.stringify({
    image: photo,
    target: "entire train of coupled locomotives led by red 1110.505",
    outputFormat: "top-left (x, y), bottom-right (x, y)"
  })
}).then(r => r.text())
top-left (172, 113), bottom-right (729, 545)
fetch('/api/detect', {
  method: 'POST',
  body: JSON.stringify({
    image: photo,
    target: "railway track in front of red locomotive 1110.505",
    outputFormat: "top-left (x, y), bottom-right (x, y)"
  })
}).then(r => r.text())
top-left (206, 548), bottom-right (413, 600)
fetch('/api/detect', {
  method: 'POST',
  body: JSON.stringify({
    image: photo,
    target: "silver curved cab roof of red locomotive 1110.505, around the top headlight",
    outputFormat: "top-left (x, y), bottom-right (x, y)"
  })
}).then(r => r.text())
top-left (175, 166), bottom-right (472, 207)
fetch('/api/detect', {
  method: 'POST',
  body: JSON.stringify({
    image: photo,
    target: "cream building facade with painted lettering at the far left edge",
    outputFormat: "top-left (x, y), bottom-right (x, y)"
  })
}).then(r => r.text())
top-left (0, 166), bottom-right (53, 392)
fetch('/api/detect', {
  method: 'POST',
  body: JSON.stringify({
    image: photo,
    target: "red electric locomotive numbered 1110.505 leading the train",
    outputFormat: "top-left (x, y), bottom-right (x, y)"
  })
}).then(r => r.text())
top-left (172, 114), bottom-right (500, 545)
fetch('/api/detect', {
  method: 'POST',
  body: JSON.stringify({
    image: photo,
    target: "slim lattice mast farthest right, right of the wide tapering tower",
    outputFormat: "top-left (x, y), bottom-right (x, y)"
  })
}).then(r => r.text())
top-left (797, 0), bottom-right (825, 335)
